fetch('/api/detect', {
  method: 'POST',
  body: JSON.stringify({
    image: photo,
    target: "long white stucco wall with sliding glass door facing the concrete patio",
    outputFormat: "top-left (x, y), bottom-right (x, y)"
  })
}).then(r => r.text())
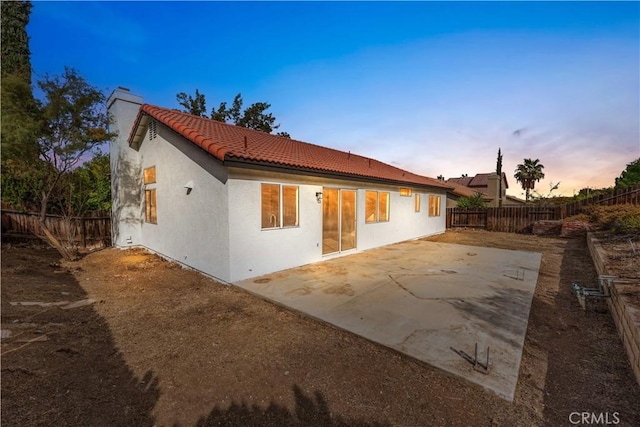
top-left (228, 171), bottom-right (446, 281)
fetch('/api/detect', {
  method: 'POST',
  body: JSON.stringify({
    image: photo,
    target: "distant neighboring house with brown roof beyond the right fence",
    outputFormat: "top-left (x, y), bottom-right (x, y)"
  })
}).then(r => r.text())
top-left (445, 172), bottom-right (525, 207)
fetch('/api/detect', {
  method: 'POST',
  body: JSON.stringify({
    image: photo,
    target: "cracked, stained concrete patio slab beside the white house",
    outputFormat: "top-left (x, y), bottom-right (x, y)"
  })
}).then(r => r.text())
top-left (235, 240), bottom-right (541, 400)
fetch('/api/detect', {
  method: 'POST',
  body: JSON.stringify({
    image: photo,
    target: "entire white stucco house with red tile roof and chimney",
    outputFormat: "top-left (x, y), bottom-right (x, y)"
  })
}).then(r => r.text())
top-left (108, 88), bottom-right (449, 282)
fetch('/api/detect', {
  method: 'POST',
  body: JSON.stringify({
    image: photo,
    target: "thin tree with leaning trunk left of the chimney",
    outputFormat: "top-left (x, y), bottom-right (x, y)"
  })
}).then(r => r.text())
top-left (38, 68), bottom-right (115, 259)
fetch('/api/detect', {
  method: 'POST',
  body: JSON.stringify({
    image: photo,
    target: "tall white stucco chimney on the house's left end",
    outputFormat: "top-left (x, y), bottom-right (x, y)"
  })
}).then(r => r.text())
top-left (107, 86), bottom-right (142, 247)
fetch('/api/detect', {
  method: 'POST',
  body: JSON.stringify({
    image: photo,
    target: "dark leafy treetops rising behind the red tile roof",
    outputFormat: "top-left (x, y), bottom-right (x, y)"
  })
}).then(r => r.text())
top-left (176, 89), bottom-right (291, 138)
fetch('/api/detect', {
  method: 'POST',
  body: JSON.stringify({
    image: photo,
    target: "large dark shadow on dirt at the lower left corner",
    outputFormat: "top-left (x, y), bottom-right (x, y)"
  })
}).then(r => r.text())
top-left (1, 248), bottom-right (159, 426)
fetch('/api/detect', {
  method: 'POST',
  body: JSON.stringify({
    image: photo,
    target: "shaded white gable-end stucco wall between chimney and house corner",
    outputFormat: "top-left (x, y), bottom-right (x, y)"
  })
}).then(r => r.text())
top-left (133, 124), bottom-right (230, 281)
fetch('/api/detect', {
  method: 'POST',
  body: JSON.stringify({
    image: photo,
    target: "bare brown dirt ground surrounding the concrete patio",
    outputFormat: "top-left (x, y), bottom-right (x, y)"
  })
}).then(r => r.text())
top-left (1, 231), bottom-right (640, 426)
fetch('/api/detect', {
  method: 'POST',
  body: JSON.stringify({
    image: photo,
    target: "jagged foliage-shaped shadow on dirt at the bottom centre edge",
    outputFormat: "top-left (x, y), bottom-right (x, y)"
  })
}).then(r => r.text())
top-left (196, 385), bottom-right (390, 427)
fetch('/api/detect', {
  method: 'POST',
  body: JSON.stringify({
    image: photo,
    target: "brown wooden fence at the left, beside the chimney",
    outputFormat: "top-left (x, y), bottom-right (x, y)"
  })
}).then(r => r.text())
top-left (2, 209), bottom-right (111, 249)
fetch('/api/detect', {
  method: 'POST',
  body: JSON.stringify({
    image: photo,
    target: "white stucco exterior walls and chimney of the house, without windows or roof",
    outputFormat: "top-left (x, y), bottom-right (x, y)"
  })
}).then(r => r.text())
top-left (109, 92), bottom-right (446, 282)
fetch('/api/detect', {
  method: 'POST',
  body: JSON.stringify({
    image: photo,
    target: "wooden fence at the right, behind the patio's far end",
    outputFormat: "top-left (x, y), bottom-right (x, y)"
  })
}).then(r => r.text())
top-left (447, 185), bottom-right (640, 233)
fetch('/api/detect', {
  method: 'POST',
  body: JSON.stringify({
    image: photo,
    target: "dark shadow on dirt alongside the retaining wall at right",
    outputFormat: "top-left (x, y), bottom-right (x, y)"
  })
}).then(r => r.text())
top-left (540, 238), bottom-right (640, 425)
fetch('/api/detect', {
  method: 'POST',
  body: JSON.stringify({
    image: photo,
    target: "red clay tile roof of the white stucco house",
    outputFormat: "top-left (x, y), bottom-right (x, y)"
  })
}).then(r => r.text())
top-left (129, 104), bottom-right (450, 189)
